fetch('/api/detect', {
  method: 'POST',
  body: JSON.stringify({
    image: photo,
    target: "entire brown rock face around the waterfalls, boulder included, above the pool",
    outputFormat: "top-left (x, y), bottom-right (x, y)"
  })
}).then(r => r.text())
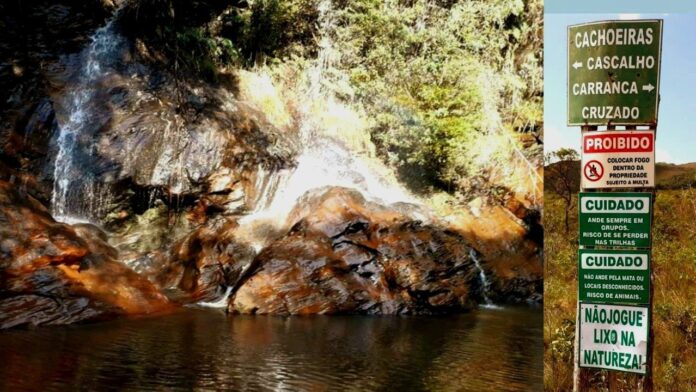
top-left (0, 0), bottom-right (542, 329)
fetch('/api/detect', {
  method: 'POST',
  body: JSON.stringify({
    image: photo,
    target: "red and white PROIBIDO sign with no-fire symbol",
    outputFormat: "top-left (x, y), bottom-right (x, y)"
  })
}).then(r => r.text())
top-left (580, 130), bottom-right (655, 189)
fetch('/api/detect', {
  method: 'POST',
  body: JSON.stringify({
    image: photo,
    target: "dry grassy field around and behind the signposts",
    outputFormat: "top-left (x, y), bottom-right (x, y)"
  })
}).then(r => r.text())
top-left (544, 188), bottom-right (696, 391)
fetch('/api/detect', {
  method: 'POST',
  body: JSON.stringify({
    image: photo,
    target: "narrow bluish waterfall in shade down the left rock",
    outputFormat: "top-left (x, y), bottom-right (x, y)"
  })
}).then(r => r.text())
top-left (51, 18), bottom-right (125, 223)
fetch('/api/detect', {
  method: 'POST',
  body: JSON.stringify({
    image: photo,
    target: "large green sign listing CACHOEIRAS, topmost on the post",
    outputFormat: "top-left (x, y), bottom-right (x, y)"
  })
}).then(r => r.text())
top-left (568, 20), bottom-right (662, 125)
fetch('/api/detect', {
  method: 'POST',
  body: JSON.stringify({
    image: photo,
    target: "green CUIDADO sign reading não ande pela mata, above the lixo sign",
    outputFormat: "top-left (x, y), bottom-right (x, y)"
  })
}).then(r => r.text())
top-left (578, 249), bottom-right (650, 305)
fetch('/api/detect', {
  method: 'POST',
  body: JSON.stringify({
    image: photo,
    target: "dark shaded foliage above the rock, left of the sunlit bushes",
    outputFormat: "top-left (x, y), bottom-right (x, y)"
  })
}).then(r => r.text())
top-left (121, 0), bottom-right (318, 82)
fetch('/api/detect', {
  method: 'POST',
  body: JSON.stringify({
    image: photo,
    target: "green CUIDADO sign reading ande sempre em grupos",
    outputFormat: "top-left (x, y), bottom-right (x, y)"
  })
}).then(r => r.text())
top-left (578, 192), bottom-right (652, 248)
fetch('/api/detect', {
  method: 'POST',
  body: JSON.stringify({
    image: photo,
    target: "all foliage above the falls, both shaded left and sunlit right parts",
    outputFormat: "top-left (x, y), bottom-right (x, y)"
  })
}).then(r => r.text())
top-left (123, 0), bottom-right (543, 202)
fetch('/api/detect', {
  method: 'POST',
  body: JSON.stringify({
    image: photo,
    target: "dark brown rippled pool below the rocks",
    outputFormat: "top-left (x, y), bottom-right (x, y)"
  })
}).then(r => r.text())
top-left (0, 308), bottom-right (543, 391)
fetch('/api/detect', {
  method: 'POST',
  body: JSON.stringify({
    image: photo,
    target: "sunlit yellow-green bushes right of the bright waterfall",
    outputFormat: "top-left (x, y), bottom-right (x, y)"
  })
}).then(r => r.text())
top-left (334, 0), bottom-right (543, 194)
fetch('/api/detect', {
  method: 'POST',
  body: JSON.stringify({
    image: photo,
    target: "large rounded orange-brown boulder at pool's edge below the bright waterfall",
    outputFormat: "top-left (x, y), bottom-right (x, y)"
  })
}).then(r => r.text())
top-left (229, 188), bottom-right (480, 315)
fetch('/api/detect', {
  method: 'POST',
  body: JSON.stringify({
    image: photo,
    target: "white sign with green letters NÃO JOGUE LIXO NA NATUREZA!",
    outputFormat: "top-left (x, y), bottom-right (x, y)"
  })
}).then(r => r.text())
top-left (580, 303), bottom-right (650, 374)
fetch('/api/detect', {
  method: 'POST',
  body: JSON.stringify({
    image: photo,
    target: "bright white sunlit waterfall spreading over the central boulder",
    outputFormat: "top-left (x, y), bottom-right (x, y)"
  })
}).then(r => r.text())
top-left (234, 0), bottom-right (420, 249)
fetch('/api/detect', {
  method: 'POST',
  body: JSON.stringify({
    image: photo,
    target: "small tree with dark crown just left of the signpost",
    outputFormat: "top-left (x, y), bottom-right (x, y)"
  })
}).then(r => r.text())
top-left (545, 148), bottom-right (580, 235)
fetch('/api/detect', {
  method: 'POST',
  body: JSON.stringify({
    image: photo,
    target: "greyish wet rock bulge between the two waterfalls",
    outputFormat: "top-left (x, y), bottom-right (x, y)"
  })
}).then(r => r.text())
top-left (97, 78), bottom-right (294, 198)
